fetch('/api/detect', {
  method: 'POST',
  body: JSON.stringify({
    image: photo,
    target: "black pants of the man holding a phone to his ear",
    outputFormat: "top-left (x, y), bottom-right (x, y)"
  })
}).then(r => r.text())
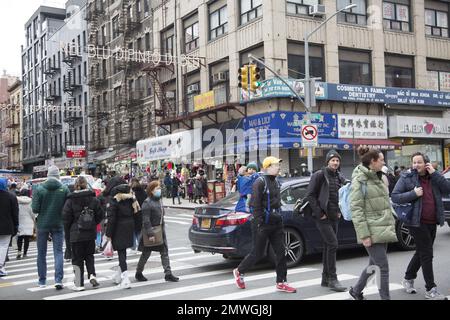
top-left (405, 223), bottom-right (437, 291)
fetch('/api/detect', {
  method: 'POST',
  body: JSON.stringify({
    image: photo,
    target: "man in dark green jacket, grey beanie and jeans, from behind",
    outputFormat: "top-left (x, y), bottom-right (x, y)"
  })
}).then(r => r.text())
top-left (31, 166), bottom-right (69, 290)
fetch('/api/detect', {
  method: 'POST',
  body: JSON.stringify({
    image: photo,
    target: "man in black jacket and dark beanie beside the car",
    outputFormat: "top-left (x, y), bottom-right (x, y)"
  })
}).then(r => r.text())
top-left (306, 150), bottom-right (347, 292)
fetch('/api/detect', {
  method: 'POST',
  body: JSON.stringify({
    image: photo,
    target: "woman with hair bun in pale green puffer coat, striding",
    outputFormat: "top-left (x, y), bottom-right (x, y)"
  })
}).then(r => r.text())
top-left (349, 146), bottom-right (397, 300)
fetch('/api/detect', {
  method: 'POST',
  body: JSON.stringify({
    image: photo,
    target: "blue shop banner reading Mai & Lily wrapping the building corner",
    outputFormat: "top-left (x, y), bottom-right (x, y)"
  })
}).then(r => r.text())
top-left (244, 111), bottom-right (338, 141)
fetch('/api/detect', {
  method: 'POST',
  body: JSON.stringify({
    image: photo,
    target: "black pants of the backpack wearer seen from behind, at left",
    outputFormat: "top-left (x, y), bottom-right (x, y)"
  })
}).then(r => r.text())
top-left (71, 240), bottom-right (95, 286)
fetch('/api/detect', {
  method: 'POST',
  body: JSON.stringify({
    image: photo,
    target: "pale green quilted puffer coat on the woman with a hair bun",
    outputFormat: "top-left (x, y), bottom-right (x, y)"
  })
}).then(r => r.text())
top-left (350, 164), bottom-right (397, 243)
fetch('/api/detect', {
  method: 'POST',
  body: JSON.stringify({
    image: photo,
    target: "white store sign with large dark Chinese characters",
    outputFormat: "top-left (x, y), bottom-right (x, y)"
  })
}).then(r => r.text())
top-left (338, 114), bottom-right (388, 139)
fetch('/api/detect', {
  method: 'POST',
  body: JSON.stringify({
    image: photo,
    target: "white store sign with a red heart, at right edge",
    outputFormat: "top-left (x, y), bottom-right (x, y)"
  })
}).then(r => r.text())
top-left (389, 116), bottom-right (450, 139)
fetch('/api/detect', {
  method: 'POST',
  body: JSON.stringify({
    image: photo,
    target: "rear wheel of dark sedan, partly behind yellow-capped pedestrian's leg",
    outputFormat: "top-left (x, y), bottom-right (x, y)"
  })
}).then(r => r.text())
top-left (268, 228), bottom-right (305, 268)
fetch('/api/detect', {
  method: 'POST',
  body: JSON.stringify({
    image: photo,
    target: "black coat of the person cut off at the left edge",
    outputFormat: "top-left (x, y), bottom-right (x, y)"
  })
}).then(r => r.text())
top-left (0, 191), bottom-right (19, 236)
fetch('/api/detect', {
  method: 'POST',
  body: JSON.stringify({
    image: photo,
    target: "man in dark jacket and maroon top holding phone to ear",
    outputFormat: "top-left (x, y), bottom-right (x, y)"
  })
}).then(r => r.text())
top-left (392, 152), bottom-right (450, 300)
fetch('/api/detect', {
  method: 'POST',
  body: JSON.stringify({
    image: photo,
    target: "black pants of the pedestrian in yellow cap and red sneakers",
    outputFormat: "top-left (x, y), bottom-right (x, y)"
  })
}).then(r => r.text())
top-left (238, 221), bottom-right (287, 283)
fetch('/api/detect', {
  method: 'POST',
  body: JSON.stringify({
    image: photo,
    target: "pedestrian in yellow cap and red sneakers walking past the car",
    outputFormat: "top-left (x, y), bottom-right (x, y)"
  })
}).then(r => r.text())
top-left (233, 157), bottom-right (297, 293)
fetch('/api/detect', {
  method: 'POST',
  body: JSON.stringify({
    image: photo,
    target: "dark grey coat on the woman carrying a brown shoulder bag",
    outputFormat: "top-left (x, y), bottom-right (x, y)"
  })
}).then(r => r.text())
top-left (138, 197), bottom-right (165, 251)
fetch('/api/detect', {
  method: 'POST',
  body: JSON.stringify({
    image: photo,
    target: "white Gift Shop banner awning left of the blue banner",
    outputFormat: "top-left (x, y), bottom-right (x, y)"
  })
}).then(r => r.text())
top-left (136, 129), bottom-right (202, 163)
